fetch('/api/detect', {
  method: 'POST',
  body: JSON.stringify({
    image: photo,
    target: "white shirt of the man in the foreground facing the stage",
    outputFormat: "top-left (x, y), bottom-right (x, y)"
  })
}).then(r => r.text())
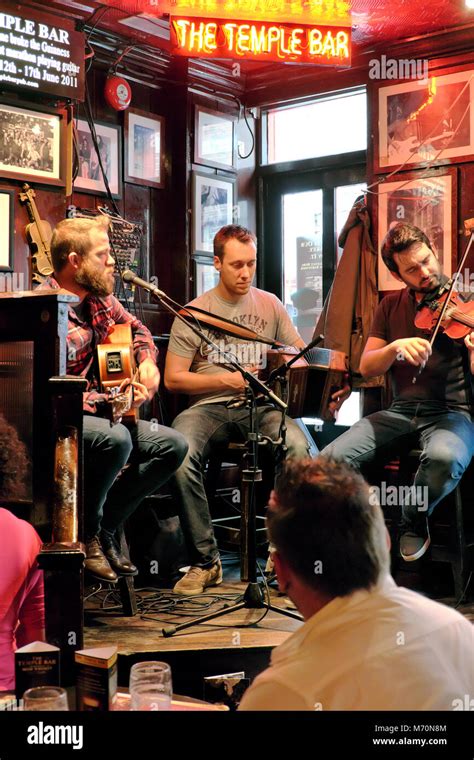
top-left (239, 575), bottom-right (474, 710)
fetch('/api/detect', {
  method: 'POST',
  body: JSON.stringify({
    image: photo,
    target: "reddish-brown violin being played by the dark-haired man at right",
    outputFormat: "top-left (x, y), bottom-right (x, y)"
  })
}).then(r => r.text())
top-left (415, 292), bottom-right (474, 340)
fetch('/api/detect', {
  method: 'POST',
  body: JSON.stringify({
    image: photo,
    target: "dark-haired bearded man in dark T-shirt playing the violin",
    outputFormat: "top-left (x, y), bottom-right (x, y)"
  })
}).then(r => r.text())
top-left (321, 222), bottom-right (474, 562)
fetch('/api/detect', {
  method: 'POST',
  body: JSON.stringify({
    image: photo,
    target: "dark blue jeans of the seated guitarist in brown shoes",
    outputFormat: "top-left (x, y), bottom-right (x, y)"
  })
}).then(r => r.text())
top-left (84, 415), bottom-right (188, 540)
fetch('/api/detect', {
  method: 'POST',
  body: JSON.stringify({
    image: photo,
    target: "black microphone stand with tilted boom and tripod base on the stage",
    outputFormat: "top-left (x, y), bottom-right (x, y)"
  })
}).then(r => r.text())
top-left (123, 270), bottom-right (304, 637)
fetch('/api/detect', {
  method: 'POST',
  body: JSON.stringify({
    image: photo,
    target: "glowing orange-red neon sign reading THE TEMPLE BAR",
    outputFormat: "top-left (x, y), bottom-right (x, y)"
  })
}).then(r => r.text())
top-left (170, 18), bottom-right (351, 66)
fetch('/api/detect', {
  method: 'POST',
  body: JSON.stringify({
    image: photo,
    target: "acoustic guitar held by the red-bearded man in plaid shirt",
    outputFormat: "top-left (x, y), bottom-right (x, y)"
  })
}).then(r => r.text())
top-left (97, 323), bottom-right (139, 425)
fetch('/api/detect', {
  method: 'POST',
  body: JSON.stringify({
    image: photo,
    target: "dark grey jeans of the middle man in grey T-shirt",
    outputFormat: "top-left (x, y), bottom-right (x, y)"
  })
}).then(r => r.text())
top-left (170, 403), bottom-right (317, 567)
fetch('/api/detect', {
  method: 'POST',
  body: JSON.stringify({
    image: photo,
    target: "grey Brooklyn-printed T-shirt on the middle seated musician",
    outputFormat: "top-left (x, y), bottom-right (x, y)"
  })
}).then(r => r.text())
top-left (169, 288), bottom-right (299, 406)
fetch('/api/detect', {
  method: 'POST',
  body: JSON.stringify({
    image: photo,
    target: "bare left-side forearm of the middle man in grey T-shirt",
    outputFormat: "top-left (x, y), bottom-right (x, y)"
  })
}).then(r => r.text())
top-left (165, 350), bottom-right (245, 396)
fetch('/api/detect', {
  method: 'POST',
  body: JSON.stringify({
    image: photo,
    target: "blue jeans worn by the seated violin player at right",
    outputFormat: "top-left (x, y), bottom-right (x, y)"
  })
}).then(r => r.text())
top-left (321, 402), bottom-right (474, 525)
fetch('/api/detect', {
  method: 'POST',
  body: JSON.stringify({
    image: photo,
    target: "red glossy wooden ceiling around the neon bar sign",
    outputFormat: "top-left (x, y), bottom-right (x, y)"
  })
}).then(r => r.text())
top-left (17, 0), bottom-right (474, 105)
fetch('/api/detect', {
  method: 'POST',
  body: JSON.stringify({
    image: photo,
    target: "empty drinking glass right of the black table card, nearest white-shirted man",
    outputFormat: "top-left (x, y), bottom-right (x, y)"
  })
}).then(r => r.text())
top-left (130, 661), bottom-right (173, 711)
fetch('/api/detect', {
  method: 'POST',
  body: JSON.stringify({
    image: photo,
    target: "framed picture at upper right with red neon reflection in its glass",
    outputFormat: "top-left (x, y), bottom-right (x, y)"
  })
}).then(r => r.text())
top-left (375, 69), bottom-right (474, 173)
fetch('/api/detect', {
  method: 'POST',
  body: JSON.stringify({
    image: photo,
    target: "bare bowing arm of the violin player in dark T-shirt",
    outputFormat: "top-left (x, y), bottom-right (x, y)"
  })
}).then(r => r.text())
top-left (360, 337), bottom-right (431, 378)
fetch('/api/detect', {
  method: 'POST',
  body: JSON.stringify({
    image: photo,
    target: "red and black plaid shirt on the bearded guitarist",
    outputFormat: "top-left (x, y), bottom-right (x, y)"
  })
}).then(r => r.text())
top-left (37, 277), bottom-right (158, 414)
